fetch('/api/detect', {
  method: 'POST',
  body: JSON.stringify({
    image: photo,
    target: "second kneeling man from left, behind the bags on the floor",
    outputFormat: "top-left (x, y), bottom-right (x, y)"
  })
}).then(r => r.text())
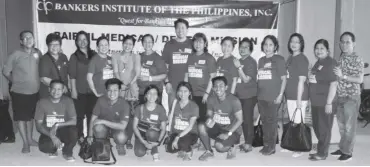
top-left (87, 78), bottom-right (130, 155)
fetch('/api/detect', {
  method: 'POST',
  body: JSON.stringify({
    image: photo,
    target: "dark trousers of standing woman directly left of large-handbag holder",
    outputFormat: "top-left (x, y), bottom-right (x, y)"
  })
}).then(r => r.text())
top-left (258, 100), bottom-right (279, 150)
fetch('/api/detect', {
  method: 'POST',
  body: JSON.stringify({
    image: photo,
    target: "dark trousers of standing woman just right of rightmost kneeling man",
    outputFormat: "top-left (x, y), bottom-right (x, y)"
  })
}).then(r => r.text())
top-left (240, 97), bottom-right (257, 144)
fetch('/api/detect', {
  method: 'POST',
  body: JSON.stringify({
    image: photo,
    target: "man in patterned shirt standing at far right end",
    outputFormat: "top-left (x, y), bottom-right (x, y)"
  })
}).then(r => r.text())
top-left (331, 32), bottom-right (364, 162)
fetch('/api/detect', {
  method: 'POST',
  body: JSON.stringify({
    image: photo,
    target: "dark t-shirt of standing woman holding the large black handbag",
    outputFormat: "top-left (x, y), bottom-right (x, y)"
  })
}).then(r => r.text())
top-left (285, 54), bottom-right (309, 101)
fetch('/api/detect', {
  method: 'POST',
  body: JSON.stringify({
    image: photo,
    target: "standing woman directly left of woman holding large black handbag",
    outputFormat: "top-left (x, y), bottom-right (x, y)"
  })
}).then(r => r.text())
top-left (257, 35), bottom-right (287, 155)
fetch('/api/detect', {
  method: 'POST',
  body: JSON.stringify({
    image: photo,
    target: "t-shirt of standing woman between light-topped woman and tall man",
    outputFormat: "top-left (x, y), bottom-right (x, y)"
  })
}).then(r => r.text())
top-left (137, 52), bottom-right (167, 95)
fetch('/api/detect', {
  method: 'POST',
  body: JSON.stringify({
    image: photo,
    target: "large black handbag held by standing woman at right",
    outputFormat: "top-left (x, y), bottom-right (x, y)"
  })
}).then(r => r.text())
top-left (280, 108), bottom-right (312, 152)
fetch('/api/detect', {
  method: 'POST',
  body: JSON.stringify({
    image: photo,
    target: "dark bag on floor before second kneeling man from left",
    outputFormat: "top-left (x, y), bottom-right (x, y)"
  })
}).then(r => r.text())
top-left (84, 139), bottom-right (117, 165)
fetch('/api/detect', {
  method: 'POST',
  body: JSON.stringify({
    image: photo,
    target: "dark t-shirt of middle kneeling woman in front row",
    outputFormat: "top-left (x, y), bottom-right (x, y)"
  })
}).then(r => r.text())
top-left (135, 104), bottom-right (167, 129)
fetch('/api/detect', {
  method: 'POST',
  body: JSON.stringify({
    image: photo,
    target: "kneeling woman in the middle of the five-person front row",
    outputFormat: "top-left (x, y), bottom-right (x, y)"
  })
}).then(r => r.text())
top-left (133, 85), bottom-right (167, 161)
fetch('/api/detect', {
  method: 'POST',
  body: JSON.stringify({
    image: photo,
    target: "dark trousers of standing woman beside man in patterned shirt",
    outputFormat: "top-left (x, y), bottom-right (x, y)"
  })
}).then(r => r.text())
top-left (311, 106), bottom-right (334, 157)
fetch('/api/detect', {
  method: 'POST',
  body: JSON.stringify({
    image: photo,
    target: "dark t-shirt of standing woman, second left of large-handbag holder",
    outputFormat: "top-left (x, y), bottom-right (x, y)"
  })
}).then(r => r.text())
top-left (235, 56), bottom-right (257, 99)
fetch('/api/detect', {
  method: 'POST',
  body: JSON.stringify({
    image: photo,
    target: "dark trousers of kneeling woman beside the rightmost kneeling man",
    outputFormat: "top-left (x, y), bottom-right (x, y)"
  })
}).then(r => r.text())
top-left (167, 133), bottom-right (198, 153)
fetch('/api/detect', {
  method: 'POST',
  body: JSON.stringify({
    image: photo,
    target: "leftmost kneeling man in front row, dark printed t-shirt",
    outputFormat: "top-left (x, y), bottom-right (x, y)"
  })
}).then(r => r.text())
top-left (35, 80), bottom-right (77, 162)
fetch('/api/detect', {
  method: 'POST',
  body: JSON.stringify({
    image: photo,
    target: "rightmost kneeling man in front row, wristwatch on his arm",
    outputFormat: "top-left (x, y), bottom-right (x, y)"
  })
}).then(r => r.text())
top-left (198, 76), bottom-right (243, 161)
